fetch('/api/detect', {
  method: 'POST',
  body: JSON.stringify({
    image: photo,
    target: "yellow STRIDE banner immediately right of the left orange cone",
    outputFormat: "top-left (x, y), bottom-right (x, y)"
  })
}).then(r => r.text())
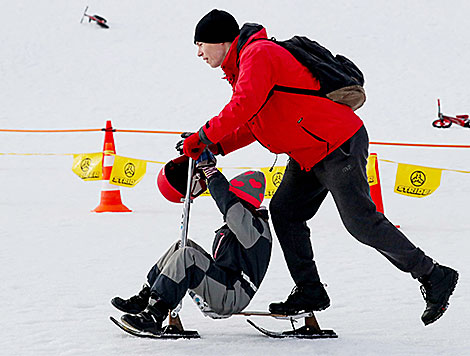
top-left (109, 156), bottom-right (147, 188)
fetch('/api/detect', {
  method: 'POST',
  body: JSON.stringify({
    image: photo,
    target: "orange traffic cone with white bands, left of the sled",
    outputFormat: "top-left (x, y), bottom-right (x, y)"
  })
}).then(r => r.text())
top-left (92, 121), bottom-right (132, 213)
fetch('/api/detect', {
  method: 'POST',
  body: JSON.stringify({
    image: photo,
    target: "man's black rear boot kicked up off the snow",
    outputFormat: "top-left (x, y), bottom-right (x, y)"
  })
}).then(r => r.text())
top-left (418, 263), bottom-right (459, 325)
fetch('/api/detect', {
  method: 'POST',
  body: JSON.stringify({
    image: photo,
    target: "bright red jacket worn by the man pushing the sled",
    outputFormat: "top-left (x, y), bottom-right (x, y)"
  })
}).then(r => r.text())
top-left (200, 24), bottom-right (362, 170)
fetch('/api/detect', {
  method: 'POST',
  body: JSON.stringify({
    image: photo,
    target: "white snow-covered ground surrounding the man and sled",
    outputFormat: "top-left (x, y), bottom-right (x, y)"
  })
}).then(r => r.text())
top-left (0, 0), bottom-right (470, 355)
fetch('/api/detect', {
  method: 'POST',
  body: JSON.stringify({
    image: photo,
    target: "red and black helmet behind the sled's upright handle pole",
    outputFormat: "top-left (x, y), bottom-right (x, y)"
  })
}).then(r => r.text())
top-left (157, 156), bottom-right (207, 203)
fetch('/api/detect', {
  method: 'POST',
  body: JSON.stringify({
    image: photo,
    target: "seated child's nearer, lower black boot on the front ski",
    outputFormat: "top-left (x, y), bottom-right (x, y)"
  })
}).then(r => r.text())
top-left (121, 299), bottom-right (170, 334)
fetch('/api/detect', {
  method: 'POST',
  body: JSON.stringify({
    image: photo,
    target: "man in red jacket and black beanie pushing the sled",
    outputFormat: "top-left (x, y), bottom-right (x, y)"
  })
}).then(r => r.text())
top-left (183, 10), bottom-right (458, 325)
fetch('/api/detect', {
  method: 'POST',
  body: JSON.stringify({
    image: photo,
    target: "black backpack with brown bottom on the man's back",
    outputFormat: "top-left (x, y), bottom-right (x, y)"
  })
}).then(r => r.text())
top-left (246, 36), bottom-right (366, 110)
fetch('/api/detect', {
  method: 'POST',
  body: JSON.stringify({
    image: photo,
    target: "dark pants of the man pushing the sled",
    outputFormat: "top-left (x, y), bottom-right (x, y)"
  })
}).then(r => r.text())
top-left (270, 127), bottom-right (433, 286)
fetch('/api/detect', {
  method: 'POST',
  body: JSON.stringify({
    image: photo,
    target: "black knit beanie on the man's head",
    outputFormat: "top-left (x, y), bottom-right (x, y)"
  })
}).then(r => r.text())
top-left (194, 9), bottom-right (240, 43)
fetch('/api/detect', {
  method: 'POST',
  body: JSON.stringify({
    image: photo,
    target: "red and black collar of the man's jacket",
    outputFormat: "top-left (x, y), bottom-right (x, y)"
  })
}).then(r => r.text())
top-left (221, 23), bottom-right (268, 84)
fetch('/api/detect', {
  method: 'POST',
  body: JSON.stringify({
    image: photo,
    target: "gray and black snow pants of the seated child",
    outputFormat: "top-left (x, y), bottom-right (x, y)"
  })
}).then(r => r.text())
top-left (147, 240), bottom-right (254, 315)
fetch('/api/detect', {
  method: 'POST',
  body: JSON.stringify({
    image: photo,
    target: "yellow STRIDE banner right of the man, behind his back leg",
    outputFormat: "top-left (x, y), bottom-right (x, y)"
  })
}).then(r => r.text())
top-left (394, 163), bottom-right (442, 198)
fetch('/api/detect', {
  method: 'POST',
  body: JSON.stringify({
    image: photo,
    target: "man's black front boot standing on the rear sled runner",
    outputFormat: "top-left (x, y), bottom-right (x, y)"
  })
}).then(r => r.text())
top-left (269, 282), bottom-right (330, 315)
